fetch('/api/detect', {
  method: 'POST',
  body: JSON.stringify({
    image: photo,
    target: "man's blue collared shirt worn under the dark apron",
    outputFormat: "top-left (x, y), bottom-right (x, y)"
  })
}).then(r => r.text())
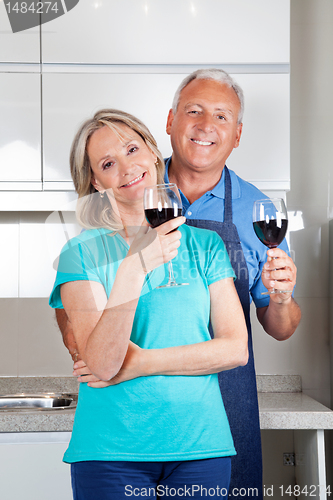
top-left (165, 157), bottom-right (289, 307)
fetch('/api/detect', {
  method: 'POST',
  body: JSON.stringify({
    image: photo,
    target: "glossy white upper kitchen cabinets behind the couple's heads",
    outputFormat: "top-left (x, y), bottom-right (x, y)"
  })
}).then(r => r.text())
top-left (0, 0), bottom-right (290, 199)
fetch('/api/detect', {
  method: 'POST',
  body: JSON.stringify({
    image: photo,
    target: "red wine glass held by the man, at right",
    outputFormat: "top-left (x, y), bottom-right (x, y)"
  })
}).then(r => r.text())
top-left (253, 198), bottom-right (292, 295)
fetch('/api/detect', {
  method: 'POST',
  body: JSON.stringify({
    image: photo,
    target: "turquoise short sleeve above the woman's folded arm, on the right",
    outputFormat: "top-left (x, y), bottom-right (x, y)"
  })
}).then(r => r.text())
top-left (206, 231), bottom-right (236, 285)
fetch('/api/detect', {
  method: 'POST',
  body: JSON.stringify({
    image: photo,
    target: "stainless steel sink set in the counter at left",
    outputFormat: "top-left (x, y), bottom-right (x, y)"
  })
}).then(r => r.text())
top-left (0, 392), bottom-right (77, 412)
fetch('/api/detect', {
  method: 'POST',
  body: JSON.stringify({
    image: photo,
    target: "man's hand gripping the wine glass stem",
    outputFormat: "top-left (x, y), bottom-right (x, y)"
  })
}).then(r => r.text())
top-left (261, 248), bottom-right (297, 303)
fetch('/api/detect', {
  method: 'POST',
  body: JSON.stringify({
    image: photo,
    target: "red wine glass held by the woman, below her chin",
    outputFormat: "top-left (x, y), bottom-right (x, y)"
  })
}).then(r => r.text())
top-left (144, 183), bottom-right (188, 288)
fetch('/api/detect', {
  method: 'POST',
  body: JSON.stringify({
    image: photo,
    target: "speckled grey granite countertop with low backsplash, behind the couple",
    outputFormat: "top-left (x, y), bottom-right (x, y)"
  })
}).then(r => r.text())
top-left (0, 375), bottom-right (333, 433)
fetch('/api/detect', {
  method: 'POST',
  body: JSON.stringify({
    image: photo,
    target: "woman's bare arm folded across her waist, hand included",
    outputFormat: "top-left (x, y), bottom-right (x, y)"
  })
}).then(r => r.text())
top-left (87, 278), bottom-right (248, 387)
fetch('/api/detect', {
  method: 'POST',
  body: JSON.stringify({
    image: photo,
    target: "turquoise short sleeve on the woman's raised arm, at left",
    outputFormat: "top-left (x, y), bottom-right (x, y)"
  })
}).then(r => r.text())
top-left (49, 238), bottom-right (101, 309)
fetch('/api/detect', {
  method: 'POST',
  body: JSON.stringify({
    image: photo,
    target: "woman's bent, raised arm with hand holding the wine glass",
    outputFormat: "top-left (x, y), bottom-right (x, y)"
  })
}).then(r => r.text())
top-left (61, 217), bottom-right (185, 380)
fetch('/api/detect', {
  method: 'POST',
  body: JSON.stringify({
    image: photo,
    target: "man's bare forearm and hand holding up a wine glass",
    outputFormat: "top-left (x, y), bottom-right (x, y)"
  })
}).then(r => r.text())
top-left (257, 248), bottom-right (301, 340)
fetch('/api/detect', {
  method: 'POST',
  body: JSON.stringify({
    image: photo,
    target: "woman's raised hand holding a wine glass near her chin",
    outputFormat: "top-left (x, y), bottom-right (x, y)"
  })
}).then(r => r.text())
top-left (128, 216), bottom-right (186, 274)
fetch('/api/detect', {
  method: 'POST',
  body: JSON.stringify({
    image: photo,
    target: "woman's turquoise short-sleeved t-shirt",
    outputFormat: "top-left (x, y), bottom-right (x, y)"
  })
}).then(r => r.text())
top-left (50, 225), bottom-right (235, 463)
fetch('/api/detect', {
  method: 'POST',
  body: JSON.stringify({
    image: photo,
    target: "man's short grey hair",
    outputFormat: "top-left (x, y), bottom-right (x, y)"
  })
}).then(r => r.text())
top-left (172, 68), bottom-right (244, 124)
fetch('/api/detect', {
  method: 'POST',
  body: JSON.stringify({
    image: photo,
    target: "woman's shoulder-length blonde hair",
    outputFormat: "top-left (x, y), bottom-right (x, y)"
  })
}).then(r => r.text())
top-left (70, 109), bottom-right (165, 231)
